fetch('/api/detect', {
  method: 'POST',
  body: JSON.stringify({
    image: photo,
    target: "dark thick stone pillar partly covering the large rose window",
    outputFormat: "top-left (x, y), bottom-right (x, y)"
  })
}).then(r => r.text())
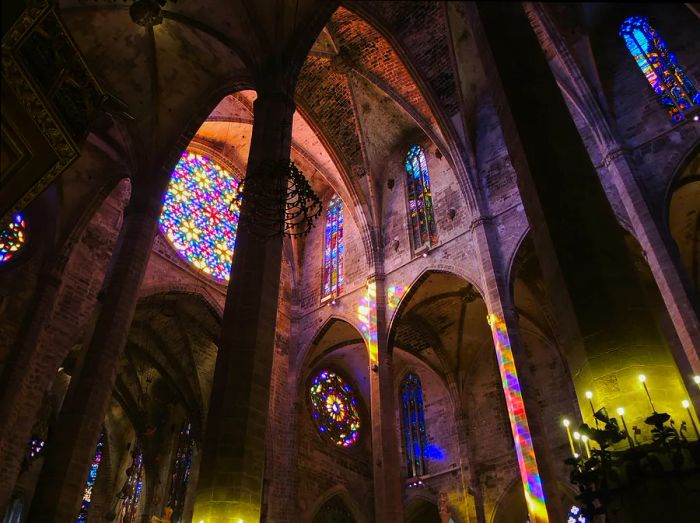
top-left (193, 92), bottom-right (295, 523)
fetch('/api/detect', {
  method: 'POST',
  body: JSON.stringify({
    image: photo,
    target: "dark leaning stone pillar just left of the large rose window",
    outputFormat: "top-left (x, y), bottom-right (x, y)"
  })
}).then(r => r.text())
top-left (28, 185), bottom-right (167, 523)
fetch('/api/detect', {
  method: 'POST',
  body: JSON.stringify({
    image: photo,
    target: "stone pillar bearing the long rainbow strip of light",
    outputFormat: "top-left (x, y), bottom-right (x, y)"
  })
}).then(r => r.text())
top-left (473, 219), bottom-right (566, 523)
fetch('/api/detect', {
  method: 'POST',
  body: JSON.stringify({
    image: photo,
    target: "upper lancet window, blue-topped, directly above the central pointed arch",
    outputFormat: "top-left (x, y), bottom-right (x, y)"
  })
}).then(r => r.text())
top-left (406, 145), bottom-right (438, 251)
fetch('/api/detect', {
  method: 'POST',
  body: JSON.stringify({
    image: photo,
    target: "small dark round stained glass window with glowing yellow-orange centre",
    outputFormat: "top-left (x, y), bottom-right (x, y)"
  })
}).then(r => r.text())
top-left (309, 370), bottom-right (360, 447)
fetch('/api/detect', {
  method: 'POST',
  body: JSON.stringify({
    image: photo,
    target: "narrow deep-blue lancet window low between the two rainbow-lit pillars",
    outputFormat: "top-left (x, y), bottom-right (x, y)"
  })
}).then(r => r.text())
top-left (401, 372), bottom-right (427, 478)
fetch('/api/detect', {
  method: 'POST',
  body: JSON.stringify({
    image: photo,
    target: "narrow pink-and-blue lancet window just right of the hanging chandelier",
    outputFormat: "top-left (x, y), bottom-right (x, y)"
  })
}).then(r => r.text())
top-left (322, 194), bottom-right (345, 300)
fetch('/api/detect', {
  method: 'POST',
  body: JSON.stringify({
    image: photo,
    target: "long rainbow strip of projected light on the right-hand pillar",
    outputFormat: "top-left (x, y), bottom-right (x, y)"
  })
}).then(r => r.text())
top-left (486, 314), bottom-right (549, 523)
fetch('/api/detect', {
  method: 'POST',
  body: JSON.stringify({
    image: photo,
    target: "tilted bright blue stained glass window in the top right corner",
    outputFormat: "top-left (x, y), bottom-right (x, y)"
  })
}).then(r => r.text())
top-left (620, 16), bottom-right (700, 122)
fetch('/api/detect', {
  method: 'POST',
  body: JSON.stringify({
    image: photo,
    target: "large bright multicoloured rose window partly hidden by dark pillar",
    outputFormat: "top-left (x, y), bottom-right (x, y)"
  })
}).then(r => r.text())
top-left (160, 152), bottom-right (239, 281)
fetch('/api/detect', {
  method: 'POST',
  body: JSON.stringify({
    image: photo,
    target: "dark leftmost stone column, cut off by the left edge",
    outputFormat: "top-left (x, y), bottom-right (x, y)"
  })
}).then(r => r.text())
top-left (0, 264), bottom-right (65, 508)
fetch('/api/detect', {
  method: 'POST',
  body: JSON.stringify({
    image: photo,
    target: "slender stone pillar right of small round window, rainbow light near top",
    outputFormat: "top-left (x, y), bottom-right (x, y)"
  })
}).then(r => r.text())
top-left (367, 275), bottom-right (403, 522)
